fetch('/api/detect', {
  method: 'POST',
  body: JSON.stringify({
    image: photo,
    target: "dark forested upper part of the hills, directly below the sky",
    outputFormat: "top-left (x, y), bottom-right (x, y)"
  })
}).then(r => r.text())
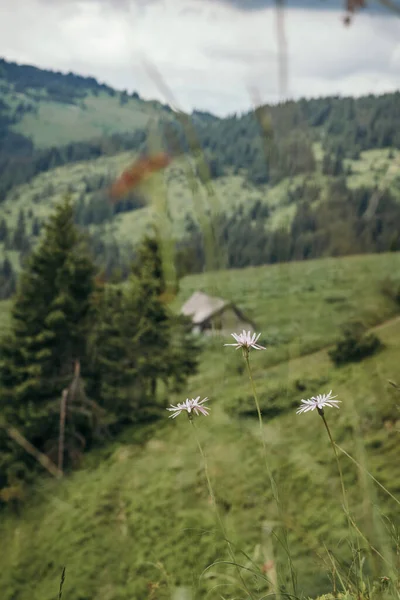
top-left (0, 60), bottom-right (400, 191)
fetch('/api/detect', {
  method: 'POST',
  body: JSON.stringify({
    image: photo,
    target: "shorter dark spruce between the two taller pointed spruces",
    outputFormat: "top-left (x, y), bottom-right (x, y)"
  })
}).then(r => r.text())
top-left (93, 276), bottom-right (166, 427)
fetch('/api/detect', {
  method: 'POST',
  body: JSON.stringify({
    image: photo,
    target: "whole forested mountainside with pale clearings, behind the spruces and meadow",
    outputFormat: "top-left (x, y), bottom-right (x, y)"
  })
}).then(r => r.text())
top-left (0, 60), bottom-right (400, 297)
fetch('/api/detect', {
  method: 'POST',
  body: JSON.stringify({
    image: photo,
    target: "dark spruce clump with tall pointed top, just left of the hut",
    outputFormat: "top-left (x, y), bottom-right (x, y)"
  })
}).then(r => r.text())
top-left (93, 238), bottom-right (199, 425)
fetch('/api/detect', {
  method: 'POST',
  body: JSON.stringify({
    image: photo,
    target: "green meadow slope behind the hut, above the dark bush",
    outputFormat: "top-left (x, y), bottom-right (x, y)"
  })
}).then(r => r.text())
top-left (175, 253), bottom-right (400, 370)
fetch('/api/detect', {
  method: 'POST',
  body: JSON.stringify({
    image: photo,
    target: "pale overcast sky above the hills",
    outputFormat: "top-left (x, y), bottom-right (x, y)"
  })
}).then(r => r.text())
top-left (0, 0), bottom-right (400, 115)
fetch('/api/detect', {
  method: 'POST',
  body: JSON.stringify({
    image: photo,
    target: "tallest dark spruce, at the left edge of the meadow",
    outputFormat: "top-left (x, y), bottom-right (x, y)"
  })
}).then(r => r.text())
top-left (0, 199), bottom-right (95, 483)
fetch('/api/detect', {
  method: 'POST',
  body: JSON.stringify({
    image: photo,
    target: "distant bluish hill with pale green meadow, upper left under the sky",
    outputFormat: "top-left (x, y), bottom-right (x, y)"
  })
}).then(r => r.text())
top-left (0, 60), bottom-right (170, 148)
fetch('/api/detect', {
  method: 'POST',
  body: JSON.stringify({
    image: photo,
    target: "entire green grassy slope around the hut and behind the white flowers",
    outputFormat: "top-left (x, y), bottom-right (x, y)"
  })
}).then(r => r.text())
top-left (0, 254), bottom-right (400, 600)
